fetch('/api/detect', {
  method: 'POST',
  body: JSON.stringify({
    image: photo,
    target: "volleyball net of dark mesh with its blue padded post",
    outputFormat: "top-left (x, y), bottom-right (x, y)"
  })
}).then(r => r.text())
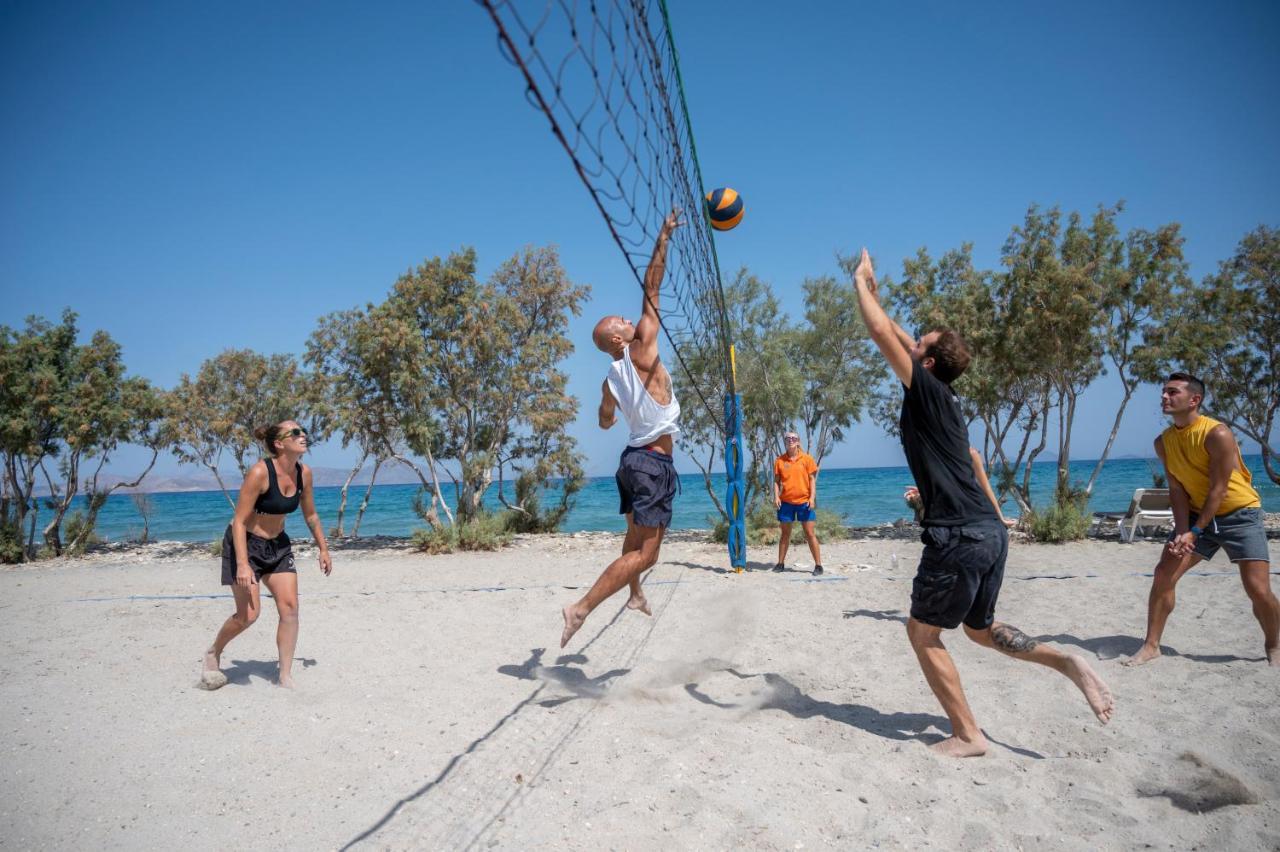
top-left (477, 0), bottom-right (746, 571)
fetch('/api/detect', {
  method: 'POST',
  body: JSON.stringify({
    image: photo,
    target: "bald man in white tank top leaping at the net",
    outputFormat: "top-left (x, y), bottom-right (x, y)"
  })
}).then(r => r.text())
top-left (561, 210), bottom-right (681, 647)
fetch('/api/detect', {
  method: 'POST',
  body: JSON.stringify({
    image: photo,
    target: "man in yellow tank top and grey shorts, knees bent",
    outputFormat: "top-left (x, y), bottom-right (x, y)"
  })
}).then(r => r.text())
top-left (1125, 372), bottom-right (1280, 667)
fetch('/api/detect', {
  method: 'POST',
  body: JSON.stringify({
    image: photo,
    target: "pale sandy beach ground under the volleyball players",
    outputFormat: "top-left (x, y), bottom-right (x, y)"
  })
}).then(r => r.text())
top-left (0, 533), bottom-right (1280, 849)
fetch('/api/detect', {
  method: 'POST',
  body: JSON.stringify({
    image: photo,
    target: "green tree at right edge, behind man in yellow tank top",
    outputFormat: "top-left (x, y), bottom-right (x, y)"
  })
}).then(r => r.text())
top-left (1146, 225), bottom-right (1280, 484)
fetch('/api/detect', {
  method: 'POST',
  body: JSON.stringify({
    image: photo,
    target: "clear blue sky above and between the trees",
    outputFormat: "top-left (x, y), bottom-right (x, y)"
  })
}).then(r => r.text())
top-left (0, 0), bottom-right (1280, 473)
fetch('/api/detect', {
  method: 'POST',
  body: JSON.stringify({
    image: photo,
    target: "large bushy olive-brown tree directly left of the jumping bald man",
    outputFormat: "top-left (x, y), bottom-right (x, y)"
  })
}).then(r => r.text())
top-left (385, 241), bottom-right (589, 522)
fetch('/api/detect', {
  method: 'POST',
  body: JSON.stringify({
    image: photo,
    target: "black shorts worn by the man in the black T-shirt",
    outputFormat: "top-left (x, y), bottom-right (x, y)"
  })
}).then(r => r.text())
top-left (911, 521), bottom-right (1009, 631)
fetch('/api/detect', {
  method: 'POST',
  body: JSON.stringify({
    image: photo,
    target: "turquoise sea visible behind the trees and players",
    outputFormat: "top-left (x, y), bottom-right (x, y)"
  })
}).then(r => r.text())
top-left (41, 457), bottom-right (1280, 541)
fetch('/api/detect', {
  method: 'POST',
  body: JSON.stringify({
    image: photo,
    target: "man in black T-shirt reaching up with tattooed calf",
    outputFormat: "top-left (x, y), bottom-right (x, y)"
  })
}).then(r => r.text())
top-left (854, 248), bottom-right (1112, 757)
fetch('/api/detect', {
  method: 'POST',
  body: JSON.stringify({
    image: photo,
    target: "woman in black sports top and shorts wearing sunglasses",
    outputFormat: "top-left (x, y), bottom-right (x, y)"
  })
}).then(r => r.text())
top-left (200, 420), bottom-right (333, 690)
